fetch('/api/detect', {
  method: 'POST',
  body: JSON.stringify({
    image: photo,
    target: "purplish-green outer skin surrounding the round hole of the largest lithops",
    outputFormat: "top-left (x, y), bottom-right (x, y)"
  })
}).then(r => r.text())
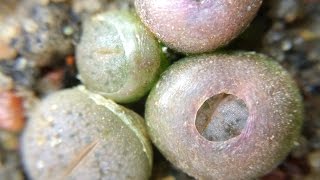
top-left (145, 53), bottom-right (302, 179)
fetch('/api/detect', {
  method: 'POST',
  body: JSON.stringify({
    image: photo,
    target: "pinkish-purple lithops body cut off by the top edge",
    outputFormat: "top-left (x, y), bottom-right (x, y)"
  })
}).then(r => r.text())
top-left (135, 0), bottom-right (262, 53)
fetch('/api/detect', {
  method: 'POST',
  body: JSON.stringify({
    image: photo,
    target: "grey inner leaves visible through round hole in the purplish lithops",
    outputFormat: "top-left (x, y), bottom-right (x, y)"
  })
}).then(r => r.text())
top-left (195, 93), bottom-right (249, 141)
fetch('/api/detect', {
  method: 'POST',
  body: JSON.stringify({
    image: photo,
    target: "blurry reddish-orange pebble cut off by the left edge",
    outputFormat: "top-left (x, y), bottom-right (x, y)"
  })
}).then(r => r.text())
top-left (0, 91), bottom-right (25, 132)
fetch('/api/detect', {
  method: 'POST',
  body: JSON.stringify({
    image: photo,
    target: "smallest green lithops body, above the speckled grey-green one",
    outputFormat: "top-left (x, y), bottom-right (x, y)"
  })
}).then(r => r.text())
top-left (76, 11), bottom-right (166, 103)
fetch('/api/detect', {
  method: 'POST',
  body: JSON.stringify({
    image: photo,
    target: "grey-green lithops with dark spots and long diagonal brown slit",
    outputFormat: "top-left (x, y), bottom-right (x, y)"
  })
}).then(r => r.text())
top-left (21, 87), bottom-right (152, 180)
